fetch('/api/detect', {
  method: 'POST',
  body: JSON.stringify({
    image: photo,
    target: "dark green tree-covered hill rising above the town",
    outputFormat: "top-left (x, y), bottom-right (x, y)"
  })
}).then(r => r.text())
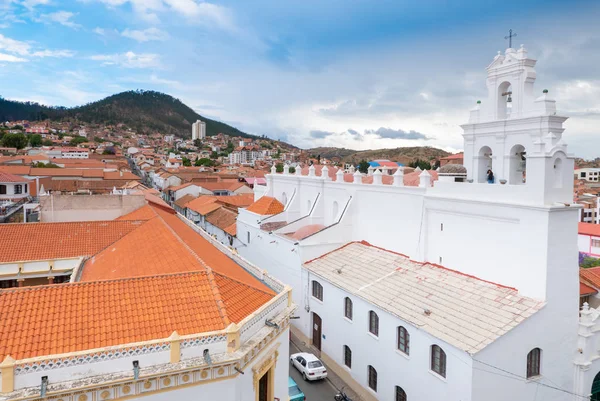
top-left (0, 90), bottom-right (256, 138)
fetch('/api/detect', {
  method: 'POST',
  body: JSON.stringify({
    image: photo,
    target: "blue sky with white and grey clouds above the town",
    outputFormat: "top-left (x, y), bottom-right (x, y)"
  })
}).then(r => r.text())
top-left (0, 0), bottom-right (600, 158)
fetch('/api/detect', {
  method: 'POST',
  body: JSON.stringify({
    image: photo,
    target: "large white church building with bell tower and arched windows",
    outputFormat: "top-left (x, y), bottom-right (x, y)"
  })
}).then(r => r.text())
top-left (237, 47), bottom-right (600, 401)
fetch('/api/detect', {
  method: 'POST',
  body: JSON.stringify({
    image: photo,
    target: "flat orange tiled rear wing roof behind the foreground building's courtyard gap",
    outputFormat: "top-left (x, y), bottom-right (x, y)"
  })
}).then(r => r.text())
top-left (0, 221), bottom-right (142, 263)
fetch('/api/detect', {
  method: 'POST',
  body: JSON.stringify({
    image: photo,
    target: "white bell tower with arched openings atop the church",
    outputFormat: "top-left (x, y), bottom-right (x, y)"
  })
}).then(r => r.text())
top-left (462, 45), bottom-right (574, 204)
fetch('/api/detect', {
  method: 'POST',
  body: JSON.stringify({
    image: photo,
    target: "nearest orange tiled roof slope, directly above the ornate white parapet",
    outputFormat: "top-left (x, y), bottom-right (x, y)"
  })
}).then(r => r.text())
top-left (0, 270), bottom-right (273, 359)
